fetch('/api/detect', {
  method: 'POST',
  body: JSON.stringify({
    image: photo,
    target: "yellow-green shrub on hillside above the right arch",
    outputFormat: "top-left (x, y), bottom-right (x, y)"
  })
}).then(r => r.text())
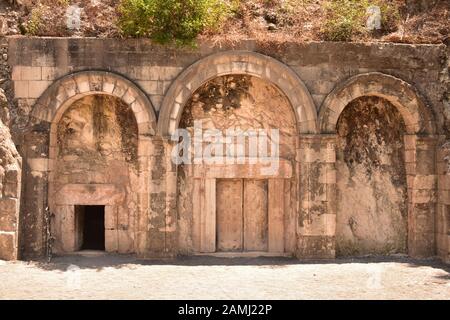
top-left (322, 0), bottom-right (400, 41)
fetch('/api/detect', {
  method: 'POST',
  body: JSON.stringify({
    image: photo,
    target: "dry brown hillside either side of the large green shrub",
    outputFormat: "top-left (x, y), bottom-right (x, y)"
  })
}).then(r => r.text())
top-left (0, 0), bottom-right (450, 43)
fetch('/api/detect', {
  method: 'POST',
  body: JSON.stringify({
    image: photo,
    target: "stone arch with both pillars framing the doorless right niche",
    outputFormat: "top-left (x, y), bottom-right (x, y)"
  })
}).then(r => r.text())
top-left (299, 72), bottom-right (437, 257)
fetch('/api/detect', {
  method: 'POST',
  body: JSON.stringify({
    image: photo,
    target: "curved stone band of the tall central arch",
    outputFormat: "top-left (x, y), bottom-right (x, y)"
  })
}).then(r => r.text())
top-left (158, 51), bottom-right (317, 137)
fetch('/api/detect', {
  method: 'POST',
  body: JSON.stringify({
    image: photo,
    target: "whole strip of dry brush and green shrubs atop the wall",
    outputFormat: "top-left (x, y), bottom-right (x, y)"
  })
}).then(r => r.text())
top-left (0, 0), bottom-right (450, 44)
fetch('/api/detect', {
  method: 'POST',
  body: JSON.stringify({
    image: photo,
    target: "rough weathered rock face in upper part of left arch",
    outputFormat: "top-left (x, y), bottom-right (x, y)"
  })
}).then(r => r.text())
top-left (58, 95), bottom-right (137, 163)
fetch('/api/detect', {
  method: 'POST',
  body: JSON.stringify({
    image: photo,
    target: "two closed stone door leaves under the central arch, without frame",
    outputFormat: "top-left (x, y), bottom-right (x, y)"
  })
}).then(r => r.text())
top-left (216, 179), bottom-right (268, 252)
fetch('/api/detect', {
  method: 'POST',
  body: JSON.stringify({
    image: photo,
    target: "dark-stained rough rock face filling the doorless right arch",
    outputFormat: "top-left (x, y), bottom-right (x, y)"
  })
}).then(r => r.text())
top-left (336, 97), bottom-right (407, 255)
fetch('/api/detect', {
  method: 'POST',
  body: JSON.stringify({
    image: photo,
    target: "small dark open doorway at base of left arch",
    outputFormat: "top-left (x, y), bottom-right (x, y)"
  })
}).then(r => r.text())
top-left (75, 206), bottom-right (105, 251)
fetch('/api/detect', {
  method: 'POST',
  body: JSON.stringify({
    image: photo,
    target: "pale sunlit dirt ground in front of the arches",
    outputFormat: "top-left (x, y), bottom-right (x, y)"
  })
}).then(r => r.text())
top-left (0, 255), bottom-right (450, 299)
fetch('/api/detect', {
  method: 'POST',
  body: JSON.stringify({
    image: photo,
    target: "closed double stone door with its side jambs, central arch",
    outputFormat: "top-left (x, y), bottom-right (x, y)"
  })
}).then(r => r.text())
top-left (188, 176), bottom-right (286, 255)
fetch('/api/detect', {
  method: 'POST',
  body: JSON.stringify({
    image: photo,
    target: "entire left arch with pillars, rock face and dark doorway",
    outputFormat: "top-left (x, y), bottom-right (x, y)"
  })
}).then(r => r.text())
top-left (23, 71), bottom-right (156, 255)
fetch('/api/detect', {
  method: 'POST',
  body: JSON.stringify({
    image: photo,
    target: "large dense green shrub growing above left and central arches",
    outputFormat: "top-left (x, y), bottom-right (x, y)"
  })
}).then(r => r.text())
top-left (118, 0), bottom-right (236, 44)
